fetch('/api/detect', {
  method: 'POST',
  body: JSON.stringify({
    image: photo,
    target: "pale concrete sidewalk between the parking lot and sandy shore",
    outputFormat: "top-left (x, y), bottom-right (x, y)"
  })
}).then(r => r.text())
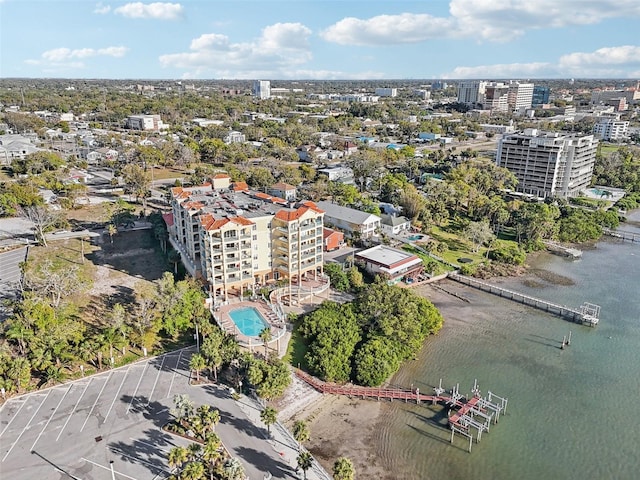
top-left (236, 395), bottom-right (332, 480)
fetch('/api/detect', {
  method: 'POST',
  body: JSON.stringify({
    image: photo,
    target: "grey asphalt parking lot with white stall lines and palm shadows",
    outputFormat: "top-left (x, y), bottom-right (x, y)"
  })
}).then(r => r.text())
top-left (0, 349), bottom-right (295, 480)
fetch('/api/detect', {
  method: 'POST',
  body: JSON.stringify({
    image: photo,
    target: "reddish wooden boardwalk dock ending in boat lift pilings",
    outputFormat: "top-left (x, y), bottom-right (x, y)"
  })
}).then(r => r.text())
top-left (294, 369), bottom-right (508, 452)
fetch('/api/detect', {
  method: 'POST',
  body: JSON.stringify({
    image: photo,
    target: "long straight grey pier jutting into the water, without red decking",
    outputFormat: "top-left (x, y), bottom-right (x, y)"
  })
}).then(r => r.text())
top-left (448, 273), bottom-right (600, 327)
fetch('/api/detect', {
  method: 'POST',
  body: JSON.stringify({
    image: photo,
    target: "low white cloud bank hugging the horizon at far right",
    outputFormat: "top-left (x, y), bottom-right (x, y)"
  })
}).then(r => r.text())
top-left (443, 45), bottom-right (640, 79)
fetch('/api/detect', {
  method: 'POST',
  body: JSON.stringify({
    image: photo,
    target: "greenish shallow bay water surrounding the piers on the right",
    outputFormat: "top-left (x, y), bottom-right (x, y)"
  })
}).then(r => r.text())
top-left (377, 213), bottom-right (640, 480)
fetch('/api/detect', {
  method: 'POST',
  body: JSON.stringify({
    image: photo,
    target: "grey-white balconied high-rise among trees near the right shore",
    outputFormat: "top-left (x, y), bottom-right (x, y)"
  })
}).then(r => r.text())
top-left (496, 128), bottom-right (598, 198)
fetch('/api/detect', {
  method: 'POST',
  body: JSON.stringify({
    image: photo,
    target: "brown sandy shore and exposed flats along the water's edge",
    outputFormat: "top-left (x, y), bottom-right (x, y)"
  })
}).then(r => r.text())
top-left (285, 264), bottom-right (573, 480)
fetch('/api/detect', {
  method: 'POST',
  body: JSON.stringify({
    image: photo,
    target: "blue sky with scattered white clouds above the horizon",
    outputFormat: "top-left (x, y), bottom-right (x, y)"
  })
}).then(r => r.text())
top-left (0, 0), bottom-right (640, 80)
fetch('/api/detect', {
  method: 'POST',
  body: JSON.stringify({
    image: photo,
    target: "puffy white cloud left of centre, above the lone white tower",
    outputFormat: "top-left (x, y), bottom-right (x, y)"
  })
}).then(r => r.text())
top-left (159, 23), bottom-right (311, 78)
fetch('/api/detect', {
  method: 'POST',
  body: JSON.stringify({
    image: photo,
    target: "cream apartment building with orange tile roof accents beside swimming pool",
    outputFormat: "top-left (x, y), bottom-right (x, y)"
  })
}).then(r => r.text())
top-left (167, 183), bottom-right (324, 302)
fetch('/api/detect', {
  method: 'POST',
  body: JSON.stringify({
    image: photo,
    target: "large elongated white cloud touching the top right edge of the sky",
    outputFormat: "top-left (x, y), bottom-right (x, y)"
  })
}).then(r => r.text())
top-left (321, 0), bottom-right (640, 45)
